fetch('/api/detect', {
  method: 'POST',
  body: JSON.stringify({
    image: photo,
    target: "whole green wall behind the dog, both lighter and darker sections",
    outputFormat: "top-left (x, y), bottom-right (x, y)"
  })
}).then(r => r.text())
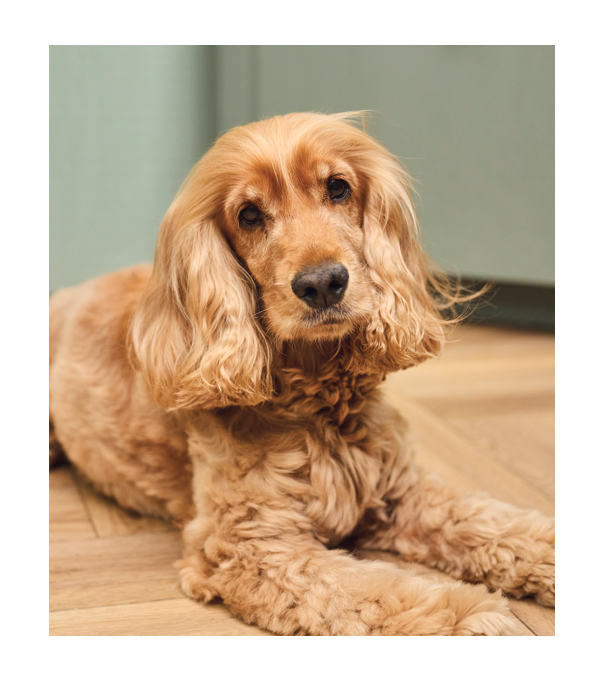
top-left (50, 45), bottom-right (555, 289)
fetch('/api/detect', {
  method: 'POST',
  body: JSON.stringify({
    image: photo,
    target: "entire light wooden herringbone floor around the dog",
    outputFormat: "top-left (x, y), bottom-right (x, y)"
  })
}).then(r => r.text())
top-left (49, 326), bottom-right (555, 636)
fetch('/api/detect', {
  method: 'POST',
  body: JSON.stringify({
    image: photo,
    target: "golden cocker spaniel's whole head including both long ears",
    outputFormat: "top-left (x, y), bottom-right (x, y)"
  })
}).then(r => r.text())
top-left (132, 113), bottom-right (452, 408)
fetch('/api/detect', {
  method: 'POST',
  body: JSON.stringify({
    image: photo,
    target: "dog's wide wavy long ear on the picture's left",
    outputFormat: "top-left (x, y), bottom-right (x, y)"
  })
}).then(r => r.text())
top-left (130, 195), bottom-right (272, 409)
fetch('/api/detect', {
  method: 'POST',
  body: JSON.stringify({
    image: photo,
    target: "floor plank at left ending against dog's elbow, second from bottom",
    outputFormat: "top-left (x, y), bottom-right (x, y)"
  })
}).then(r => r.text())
top-left (49, 532), bottom-right (182, 610)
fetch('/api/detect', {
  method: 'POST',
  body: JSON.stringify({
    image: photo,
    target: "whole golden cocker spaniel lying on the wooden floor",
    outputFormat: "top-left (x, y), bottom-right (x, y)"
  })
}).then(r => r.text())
top-left (49, 113), bottom-right (555, 636)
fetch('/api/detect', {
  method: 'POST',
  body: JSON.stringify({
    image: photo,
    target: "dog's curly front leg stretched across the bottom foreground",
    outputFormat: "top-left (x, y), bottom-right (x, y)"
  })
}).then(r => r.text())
top-left (179, 498), bottom-right (516, 635)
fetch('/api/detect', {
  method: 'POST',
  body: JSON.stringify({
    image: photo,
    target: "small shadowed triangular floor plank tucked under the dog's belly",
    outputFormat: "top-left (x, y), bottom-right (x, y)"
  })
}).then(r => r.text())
top-left (74, 473), bottom-right (177, 537)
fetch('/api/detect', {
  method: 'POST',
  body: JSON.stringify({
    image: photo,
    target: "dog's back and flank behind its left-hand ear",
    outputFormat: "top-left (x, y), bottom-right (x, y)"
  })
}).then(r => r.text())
top-left (49, 265), bottom-right (190, 517)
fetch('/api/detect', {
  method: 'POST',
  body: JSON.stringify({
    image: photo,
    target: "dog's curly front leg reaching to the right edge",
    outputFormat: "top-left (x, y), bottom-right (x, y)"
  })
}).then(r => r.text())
top-left (359, 465), bottom-right (555, 606)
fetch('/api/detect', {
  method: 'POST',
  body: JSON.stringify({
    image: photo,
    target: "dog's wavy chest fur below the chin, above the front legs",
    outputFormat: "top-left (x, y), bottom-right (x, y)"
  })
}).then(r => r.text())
top-left (183, 364), bottom-right (402, 545)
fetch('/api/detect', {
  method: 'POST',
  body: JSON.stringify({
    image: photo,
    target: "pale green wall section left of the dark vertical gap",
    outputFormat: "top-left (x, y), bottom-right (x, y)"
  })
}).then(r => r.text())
top-left (49, 45), bottom-right (216, 290)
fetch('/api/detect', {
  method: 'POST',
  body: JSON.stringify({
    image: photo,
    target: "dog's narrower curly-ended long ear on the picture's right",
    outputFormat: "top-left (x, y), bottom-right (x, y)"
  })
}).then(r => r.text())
top-left (354, 139), bottom-right (447, 370)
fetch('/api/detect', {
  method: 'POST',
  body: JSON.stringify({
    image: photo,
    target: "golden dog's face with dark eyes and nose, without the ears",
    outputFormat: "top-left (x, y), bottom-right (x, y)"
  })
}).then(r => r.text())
top-left (219, 135), bottom-right (375, 341)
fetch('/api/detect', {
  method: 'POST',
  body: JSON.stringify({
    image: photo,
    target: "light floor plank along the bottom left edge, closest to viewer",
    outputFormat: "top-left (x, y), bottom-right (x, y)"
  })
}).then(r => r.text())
top-left (48, 598), bottom-right (273, 637)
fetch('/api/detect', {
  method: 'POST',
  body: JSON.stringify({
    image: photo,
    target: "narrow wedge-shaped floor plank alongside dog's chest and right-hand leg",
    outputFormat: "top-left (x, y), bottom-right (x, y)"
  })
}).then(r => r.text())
top-left (384, 390), bottom-right (555, 515)
